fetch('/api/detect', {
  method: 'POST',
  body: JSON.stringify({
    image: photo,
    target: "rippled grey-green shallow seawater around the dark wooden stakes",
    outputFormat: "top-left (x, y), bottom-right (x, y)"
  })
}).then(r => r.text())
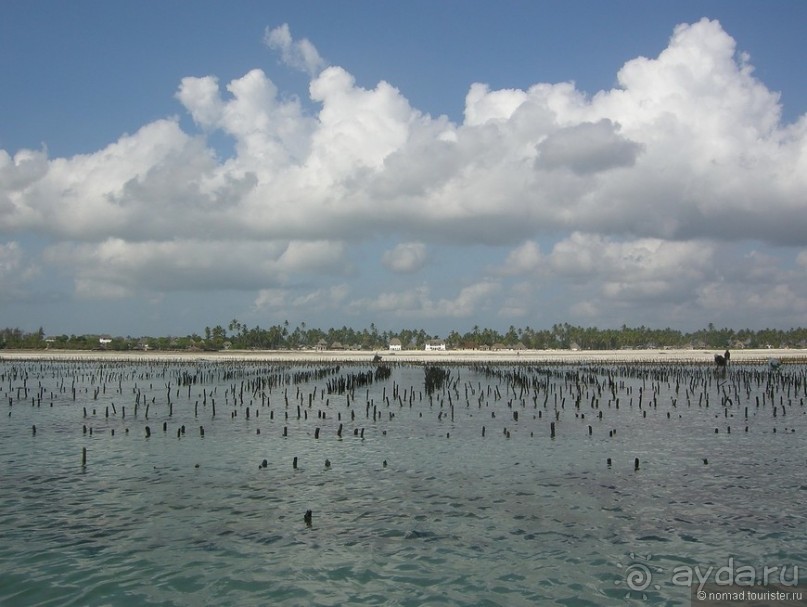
top-left (0, 361), bottom-right (807, 606)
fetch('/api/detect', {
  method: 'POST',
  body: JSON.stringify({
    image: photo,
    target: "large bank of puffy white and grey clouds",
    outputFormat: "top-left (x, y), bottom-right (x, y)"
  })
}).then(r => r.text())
top-left (0, 19), bottom-right (807, 324)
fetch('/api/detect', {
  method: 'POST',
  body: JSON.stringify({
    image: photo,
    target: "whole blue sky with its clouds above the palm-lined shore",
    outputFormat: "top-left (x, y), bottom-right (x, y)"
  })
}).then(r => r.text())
top-left (0, 0), bottom-right (807, 336)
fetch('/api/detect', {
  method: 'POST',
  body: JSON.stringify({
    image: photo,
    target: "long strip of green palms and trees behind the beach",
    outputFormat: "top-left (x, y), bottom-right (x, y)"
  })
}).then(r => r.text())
top-left (0, 319), bottom-right (807, 351)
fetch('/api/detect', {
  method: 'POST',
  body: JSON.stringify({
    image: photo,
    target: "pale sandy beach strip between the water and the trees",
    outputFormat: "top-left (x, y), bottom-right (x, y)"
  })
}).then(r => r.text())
top-left (0, 349), bottom-right (807, 364)
